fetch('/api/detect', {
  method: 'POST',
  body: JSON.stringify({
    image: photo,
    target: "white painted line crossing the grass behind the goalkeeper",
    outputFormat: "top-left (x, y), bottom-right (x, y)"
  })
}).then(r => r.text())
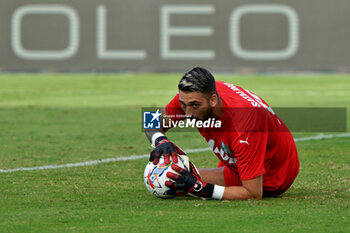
top-left (0, 133), bottom-right (350, 173)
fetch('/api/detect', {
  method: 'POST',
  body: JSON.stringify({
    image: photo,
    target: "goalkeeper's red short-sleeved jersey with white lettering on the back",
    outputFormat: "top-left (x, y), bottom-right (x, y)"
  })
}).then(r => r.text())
top-left (165, 81), bottom-right (299, 191)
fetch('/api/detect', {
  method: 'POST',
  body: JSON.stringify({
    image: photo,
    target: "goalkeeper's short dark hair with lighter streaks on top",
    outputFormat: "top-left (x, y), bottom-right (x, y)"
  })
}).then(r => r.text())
top-left (178, 67), bottom-right (217, 94)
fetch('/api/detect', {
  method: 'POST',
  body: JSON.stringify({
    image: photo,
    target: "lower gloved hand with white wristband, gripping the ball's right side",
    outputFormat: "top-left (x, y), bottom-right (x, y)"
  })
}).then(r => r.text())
top-left (165, 162), bottom-right (214, 198)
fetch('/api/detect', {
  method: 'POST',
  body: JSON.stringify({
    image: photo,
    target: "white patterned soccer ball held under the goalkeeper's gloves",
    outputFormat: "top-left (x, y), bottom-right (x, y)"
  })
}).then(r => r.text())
top-left (143, 155), bottom-right (189, 199)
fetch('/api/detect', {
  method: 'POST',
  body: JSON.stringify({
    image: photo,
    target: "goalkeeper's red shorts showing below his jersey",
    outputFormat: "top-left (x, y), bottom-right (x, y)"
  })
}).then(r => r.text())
top-left (218, 161), bottom-right (292, 197)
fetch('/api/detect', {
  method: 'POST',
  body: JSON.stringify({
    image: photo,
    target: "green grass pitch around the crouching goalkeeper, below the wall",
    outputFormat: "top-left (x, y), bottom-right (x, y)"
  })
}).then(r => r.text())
top-left (0, 74), bottom-right (350, 233)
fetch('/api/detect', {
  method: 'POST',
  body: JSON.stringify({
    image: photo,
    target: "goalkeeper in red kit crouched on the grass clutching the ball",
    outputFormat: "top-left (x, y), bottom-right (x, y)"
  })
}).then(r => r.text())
top-left (146, 67), bottom-right (299, 200)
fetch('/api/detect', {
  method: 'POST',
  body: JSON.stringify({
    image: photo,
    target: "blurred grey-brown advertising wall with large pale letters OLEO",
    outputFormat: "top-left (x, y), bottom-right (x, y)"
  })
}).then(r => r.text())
top-left (0, 0), bottom-right (350, 72)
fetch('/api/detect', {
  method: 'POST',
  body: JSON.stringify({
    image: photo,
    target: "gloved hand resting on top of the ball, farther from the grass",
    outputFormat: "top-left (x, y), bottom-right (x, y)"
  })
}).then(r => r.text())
top-left (149, 136), bottom-right (186, 164)
